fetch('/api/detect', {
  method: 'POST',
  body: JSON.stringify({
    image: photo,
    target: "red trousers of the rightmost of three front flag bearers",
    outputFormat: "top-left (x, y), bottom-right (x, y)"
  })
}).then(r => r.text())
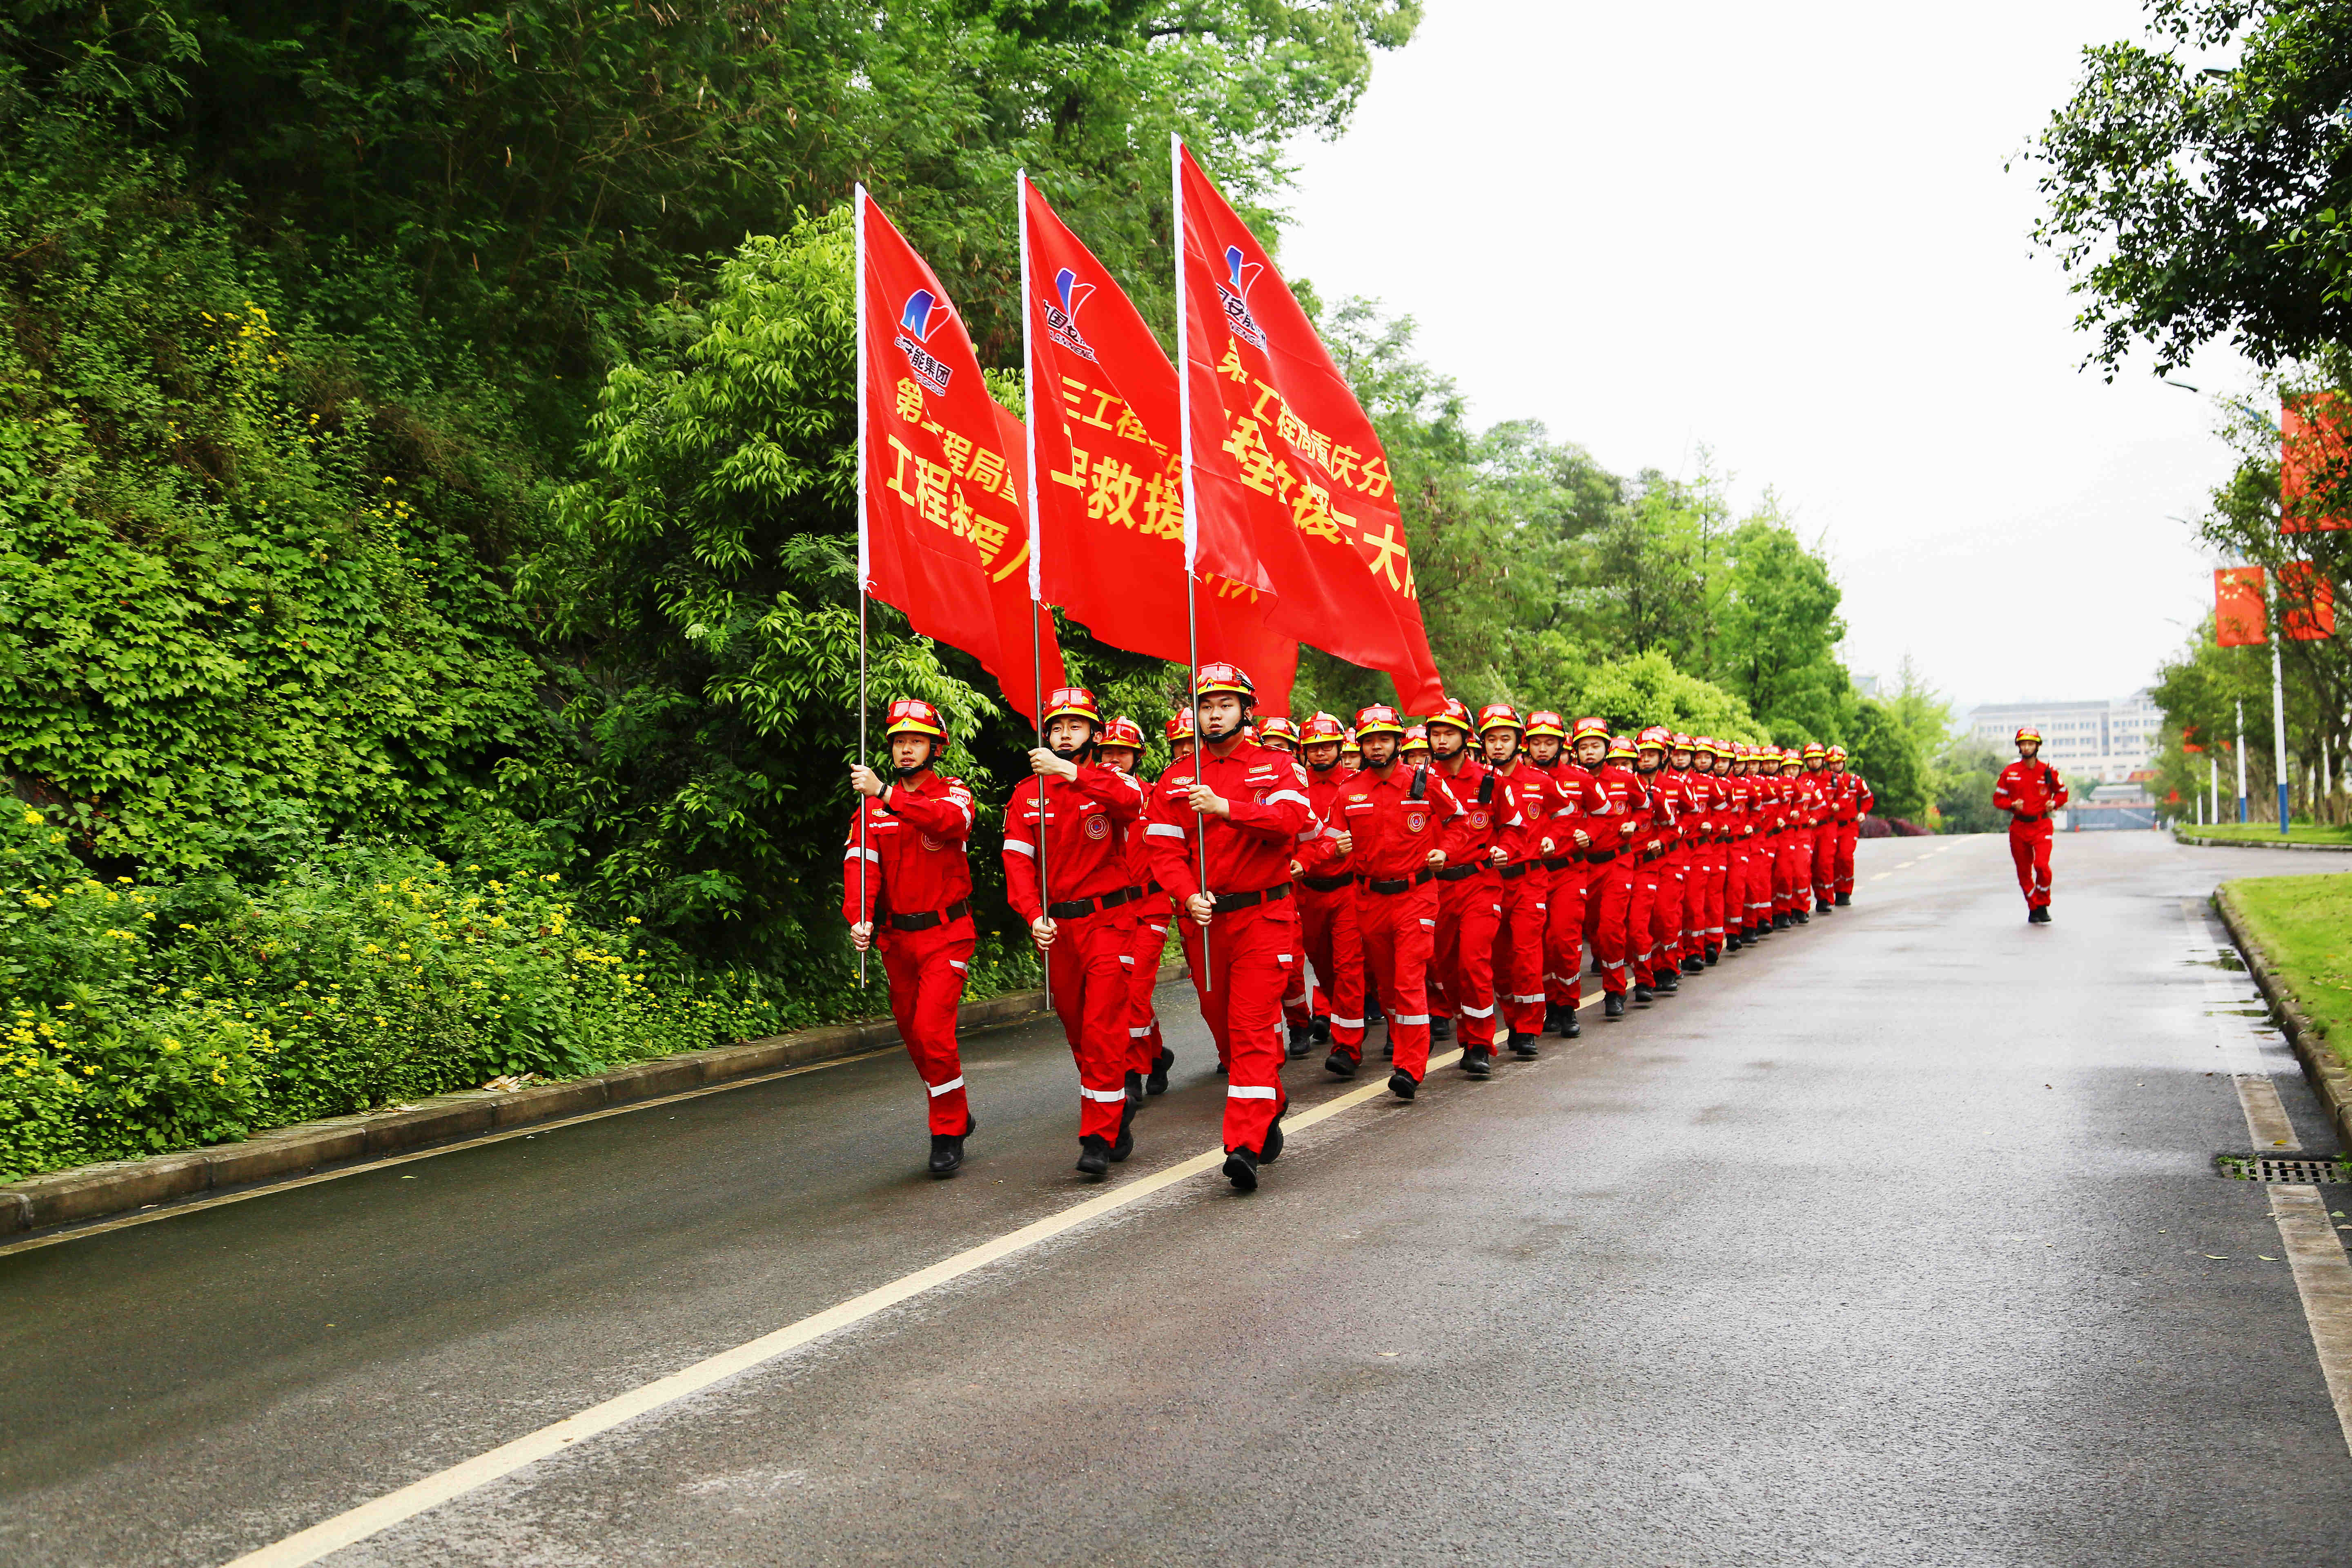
top-left (1183, 898), bottom-right (1301, 1154)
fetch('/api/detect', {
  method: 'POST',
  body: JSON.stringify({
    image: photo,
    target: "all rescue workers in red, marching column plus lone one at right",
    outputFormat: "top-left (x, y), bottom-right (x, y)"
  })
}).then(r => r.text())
top-left (842, 663), bottom-right (1882, 1192)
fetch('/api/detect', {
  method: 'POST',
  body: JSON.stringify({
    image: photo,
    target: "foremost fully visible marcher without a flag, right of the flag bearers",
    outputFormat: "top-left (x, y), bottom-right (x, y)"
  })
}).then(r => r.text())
top-left (1331, 703), bottom-right (1463, 1100)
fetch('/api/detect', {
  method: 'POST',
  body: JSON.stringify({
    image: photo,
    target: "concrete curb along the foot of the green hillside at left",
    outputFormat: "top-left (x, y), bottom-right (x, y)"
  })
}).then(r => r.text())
top-left (0, 964), bottom-right (1185, 1234)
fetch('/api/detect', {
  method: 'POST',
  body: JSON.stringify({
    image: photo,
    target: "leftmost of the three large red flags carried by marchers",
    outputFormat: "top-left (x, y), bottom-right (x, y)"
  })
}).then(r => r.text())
top-left (858, 186), bottom-right (1063, 712)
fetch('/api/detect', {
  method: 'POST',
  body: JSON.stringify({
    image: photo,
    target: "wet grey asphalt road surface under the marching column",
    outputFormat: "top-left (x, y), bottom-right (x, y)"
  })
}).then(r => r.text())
top-left (0, 835), bottom-right (2352, 1568)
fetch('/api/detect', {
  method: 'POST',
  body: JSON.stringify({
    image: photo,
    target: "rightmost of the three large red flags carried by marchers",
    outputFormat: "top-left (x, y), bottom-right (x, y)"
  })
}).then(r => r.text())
top-left (1171, 139), bottom-right (1444, 712)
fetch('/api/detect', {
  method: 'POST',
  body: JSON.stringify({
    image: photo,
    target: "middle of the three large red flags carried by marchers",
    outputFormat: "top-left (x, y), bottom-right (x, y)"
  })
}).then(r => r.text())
top-left (1018, 176), bottom-right (1298, 715)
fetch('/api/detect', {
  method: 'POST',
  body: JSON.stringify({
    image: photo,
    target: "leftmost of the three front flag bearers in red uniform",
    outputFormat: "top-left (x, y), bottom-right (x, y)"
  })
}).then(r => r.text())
top-left (842, 698), bottom-right (976, 1176)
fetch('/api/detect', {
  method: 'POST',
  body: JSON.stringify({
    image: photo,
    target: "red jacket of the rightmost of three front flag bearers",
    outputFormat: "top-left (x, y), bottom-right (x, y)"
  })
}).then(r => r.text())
top-left (1143, 740), bottom-right (1322, 903)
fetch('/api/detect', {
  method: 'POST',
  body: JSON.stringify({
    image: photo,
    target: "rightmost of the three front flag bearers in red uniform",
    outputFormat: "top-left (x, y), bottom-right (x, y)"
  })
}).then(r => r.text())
top-left (1145, 663), bottom-right (1322, 1192)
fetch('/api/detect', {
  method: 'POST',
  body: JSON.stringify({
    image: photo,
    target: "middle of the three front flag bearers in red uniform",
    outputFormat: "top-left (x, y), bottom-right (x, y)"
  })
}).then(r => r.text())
top-left (1004, 686), bottom-right (1143, 1176)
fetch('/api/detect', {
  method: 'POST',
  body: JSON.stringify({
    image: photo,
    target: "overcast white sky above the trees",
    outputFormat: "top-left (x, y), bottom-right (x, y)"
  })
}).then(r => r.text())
top-left (1282, 0), bottom-right (2251, 705)
